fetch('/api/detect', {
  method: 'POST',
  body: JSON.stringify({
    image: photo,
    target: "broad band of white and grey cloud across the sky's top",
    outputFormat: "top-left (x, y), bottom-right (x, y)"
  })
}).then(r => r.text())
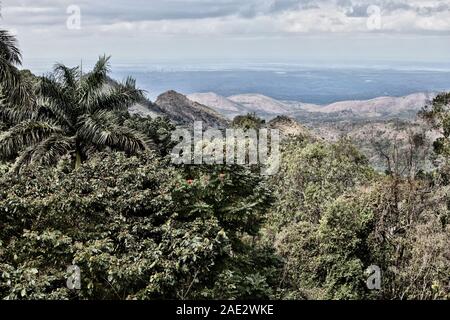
top-left (3, 0), bottom-right (450, 35)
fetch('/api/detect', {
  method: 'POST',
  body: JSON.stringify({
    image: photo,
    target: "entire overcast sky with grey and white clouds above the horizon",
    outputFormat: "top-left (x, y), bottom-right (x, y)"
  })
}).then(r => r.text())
top-left (0, 0), bottom-right (450, 64)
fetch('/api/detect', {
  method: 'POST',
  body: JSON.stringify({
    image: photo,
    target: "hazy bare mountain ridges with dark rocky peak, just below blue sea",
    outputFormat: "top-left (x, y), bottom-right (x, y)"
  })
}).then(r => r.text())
top-left (120, 74), bottom-right (436, 132)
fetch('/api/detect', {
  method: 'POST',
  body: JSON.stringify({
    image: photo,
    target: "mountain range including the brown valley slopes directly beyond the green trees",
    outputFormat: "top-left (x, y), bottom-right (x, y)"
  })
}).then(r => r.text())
top-left (122, 85), bottom-right (439, 170)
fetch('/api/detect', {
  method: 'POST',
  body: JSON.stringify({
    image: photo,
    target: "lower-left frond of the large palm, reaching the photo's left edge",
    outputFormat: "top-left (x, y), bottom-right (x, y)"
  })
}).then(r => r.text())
top-left (0, 120), bottom-right (62, 158)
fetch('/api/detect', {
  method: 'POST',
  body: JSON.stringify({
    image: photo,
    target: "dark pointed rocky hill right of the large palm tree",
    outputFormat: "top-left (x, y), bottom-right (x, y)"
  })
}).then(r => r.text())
top-left (155, 91), bottom-right (229, 128)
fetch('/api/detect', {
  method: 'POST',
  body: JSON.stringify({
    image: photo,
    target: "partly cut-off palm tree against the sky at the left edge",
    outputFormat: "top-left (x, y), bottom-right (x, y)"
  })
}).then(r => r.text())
top-left (0, 30), bottom-right (32, 104)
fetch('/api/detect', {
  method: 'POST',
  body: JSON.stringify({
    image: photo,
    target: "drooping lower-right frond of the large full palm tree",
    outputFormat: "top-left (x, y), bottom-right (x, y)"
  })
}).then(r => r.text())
top-left (78, 111), bottom-right (148, 153)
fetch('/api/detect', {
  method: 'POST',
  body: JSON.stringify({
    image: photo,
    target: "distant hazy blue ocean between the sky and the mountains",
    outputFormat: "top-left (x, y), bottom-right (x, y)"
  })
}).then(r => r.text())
top-left (23, 63), bottom-right (450, 104)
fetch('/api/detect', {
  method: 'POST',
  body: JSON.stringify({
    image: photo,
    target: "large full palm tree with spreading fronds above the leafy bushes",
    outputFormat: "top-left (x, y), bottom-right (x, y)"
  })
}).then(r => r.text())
top-left (0, 56), bottom-right (148, 170)
